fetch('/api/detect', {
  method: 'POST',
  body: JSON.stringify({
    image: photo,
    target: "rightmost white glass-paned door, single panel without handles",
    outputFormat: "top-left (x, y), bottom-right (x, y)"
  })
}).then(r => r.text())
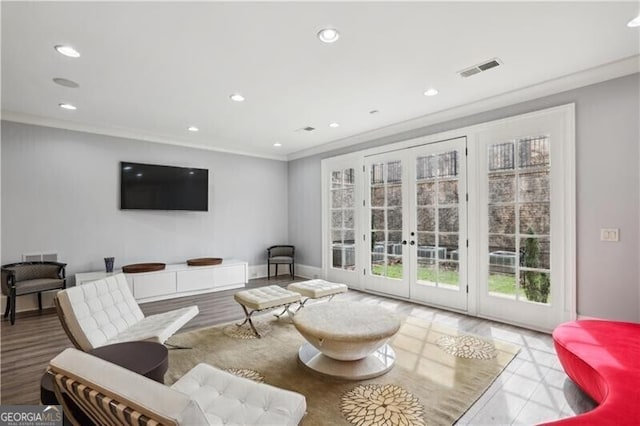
top-left (475, 109), bottom-right (573, 330)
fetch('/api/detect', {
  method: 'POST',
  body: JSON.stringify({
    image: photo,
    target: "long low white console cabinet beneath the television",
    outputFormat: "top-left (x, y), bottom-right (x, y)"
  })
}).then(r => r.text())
top-left (76, 259), bottom-right (248, 303)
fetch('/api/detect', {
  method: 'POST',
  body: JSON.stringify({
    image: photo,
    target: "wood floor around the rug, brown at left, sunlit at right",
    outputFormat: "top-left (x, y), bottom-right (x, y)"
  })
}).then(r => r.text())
top-left (0, 275), bottom-right (595, 425)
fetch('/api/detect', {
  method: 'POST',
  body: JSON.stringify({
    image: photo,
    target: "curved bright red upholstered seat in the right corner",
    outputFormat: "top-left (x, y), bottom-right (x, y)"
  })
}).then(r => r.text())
top-left (547, 320), bottom-right (640, 426)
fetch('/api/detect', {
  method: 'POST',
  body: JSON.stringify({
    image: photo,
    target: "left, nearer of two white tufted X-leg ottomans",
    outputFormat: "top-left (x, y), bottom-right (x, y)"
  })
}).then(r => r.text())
top-left (233, 285), bottom-right (300, 337)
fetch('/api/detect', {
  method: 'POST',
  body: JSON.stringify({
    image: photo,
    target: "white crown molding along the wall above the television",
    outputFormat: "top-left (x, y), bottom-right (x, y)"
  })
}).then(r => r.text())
top-left (0, 110), bottom-right (287, 161)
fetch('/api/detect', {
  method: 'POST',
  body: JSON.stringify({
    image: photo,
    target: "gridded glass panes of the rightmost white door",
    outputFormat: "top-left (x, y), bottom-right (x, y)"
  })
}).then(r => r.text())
top-left (487, 136), bottom-right (551, 304)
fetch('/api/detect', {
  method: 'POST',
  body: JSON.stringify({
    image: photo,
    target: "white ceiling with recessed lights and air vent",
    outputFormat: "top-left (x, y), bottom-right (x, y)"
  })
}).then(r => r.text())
top-left (2, 1), bottom-right (640, 158)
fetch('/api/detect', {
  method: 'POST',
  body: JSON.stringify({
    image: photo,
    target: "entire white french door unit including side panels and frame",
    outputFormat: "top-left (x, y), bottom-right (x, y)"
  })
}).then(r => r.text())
top-left (323, 105), bottom-right (576, 330)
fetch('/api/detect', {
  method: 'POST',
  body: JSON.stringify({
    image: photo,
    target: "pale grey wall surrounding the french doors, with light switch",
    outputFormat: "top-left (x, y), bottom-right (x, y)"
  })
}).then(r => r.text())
top-left (289, 74), bottom-right (640, 321)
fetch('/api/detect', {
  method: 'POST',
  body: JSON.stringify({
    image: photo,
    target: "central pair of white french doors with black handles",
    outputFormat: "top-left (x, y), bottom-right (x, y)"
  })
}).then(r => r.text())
top-left (363, 138), bottom-right (467, 310)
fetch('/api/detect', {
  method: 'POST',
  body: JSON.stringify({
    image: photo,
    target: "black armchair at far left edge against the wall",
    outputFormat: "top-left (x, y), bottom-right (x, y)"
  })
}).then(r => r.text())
top-left (1, 262), bottom-right (67, 325)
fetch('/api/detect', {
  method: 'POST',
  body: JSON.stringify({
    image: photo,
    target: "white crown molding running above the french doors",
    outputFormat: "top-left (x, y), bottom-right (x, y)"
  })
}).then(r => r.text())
top-left (287, 55), bottom-right (640, 161)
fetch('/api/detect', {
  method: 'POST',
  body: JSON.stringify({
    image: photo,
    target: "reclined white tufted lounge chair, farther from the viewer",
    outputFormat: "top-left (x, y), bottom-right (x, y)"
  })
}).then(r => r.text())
top-left (56, 274), bottom-right (198, 351)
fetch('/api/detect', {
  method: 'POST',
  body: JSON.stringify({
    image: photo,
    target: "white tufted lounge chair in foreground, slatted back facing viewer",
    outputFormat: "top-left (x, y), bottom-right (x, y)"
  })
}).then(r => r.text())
top-left (49, 349), bottom-right (307, 426)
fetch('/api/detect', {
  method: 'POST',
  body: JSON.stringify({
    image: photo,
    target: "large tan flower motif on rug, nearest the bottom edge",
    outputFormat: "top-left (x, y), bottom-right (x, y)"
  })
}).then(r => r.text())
top-left (340, 384), bottom-right (426, 426)
